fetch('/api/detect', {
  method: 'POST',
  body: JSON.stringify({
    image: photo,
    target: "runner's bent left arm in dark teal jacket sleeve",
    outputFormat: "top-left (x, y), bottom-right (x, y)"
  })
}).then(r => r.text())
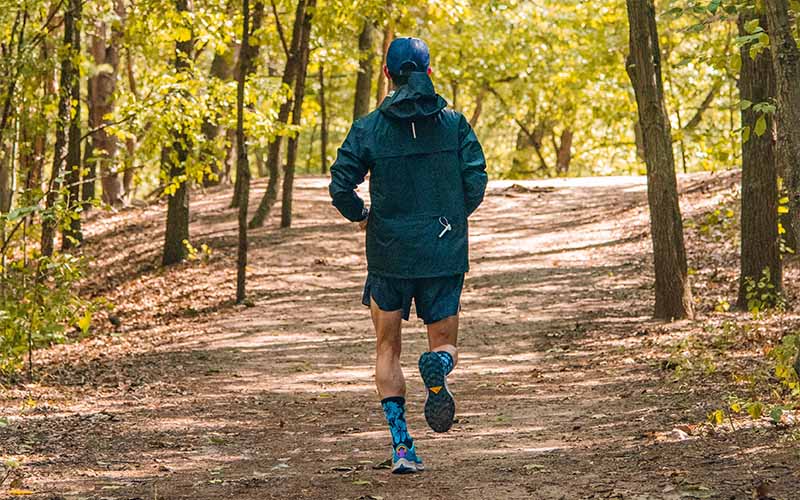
top-left (328, 124), bottom-right (369, 222)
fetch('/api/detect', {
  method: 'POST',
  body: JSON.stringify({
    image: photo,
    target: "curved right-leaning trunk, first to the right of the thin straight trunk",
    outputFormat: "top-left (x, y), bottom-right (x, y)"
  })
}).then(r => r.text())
top-left (249, 0), bottom-right (308, 229)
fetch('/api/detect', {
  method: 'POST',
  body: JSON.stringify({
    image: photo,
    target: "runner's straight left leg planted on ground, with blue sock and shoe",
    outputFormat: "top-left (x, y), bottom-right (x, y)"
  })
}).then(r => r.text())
top-left (370, 300), bottom-right (424, 474)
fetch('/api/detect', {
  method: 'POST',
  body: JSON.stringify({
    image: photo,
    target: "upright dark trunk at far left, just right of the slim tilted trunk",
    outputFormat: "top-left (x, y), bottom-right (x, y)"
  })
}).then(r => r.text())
top-left (61, 0), bottom-right (83, 250)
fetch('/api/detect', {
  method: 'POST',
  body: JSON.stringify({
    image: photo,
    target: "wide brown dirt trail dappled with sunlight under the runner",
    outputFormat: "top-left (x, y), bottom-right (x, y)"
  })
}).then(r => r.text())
top-left (0, 174), bottom-right (800, 500)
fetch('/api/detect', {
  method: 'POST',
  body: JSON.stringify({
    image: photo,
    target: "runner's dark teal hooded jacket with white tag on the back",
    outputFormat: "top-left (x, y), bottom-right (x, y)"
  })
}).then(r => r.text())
top-left (330, 72), bottom-right (487, 278)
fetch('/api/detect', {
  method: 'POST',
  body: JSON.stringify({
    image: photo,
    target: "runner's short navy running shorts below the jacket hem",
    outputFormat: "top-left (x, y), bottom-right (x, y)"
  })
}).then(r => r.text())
top-left (361, 273), bottom-right (464, 325)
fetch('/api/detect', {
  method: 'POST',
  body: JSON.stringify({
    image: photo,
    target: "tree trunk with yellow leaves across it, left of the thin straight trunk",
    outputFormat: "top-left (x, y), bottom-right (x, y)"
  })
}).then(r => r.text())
top-left (162, 0), bottom-right (194, 266)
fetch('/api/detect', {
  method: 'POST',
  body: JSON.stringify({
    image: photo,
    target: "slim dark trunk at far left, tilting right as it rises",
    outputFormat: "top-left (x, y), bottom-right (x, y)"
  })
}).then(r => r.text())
top-left (41, 0), bottom-right (80, 257)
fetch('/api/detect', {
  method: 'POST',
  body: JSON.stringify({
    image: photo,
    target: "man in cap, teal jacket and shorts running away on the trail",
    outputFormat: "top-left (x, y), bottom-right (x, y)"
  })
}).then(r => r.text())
top-left (330, 38), bottom-right (487, 474)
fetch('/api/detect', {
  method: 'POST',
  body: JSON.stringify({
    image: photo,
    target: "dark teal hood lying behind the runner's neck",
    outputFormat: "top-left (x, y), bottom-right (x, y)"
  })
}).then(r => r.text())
top-left (379, 72), bottom-right (447, 120)
